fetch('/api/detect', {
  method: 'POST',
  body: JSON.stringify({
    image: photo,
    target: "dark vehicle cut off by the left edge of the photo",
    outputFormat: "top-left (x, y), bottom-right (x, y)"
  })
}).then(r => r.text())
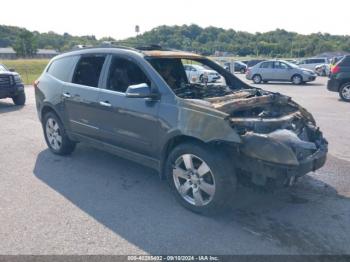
top-left (0, 64), bottom-right (26, 105)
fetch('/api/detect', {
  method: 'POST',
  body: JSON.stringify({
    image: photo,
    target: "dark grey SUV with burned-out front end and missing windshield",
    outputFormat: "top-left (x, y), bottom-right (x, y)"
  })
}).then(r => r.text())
top-left (35, 47), bottom-right (327, 213)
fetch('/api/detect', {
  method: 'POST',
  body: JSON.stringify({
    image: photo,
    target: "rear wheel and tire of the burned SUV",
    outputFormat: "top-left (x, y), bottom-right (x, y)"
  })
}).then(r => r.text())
top-left (42, 112), bottom-right (76, 155)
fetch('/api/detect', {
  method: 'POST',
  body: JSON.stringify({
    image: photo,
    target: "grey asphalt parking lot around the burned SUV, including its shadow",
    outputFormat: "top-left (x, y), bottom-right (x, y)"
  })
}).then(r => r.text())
top-left (0, 75), bottom-right (350, 255)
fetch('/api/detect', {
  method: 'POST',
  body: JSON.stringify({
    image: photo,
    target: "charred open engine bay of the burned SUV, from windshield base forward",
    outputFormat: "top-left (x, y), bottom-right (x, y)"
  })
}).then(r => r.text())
top-left (176, 84), bottom-right (327, 175)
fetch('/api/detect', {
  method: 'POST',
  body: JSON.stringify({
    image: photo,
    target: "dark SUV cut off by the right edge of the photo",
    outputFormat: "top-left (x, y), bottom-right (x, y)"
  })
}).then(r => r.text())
top-left (327, 56), bottom-right (350, 102)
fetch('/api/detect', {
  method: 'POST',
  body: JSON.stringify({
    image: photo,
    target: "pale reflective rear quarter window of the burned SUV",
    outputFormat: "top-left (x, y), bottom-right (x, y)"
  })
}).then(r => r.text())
top-left (47, 56), bottom-right (77, 82)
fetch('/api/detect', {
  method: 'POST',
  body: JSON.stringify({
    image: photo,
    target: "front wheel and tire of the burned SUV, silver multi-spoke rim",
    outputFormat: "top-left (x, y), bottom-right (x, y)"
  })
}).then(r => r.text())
top-left (165, 142), bottom-right (237, 215)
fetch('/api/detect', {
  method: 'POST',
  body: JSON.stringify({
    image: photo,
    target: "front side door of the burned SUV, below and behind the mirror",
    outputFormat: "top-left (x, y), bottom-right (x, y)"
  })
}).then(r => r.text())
top-left (98, 55), bottom-right (161, 156)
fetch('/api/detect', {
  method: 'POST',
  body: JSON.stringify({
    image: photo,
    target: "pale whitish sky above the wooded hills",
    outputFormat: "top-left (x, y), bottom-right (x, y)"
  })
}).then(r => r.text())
top-left (0, 0), bottom-right (350, 39)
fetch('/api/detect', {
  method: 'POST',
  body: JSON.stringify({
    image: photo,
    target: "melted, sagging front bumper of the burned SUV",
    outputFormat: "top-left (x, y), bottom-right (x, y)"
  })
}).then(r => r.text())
top-left (237, 129), bottom-right (328, 186)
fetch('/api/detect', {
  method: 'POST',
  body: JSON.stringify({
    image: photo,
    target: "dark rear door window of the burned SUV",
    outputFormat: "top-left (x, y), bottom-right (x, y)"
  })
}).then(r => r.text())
top-left (72, 55), bottom-right (106, 87)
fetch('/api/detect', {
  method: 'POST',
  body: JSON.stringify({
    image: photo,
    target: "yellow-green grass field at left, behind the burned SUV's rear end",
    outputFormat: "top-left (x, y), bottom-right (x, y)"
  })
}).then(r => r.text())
top-left (0, 59), bottom-right (49, 85)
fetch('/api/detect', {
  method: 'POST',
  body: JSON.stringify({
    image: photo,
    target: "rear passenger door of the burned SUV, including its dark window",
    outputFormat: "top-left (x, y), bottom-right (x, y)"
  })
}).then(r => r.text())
top-left (62, 54), bottom-right (106, 138)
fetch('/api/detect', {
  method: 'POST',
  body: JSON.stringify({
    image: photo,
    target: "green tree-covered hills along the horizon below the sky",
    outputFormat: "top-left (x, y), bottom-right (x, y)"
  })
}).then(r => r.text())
top-left (0, 24), bottom-right (350, 57)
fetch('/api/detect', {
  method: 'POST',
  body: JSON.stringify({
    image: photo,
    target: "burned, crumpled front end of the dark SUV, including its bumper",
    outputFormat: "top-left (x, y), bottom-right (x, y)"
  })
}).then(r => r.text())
top-left (205, 89), bottom-right (328, 185)
